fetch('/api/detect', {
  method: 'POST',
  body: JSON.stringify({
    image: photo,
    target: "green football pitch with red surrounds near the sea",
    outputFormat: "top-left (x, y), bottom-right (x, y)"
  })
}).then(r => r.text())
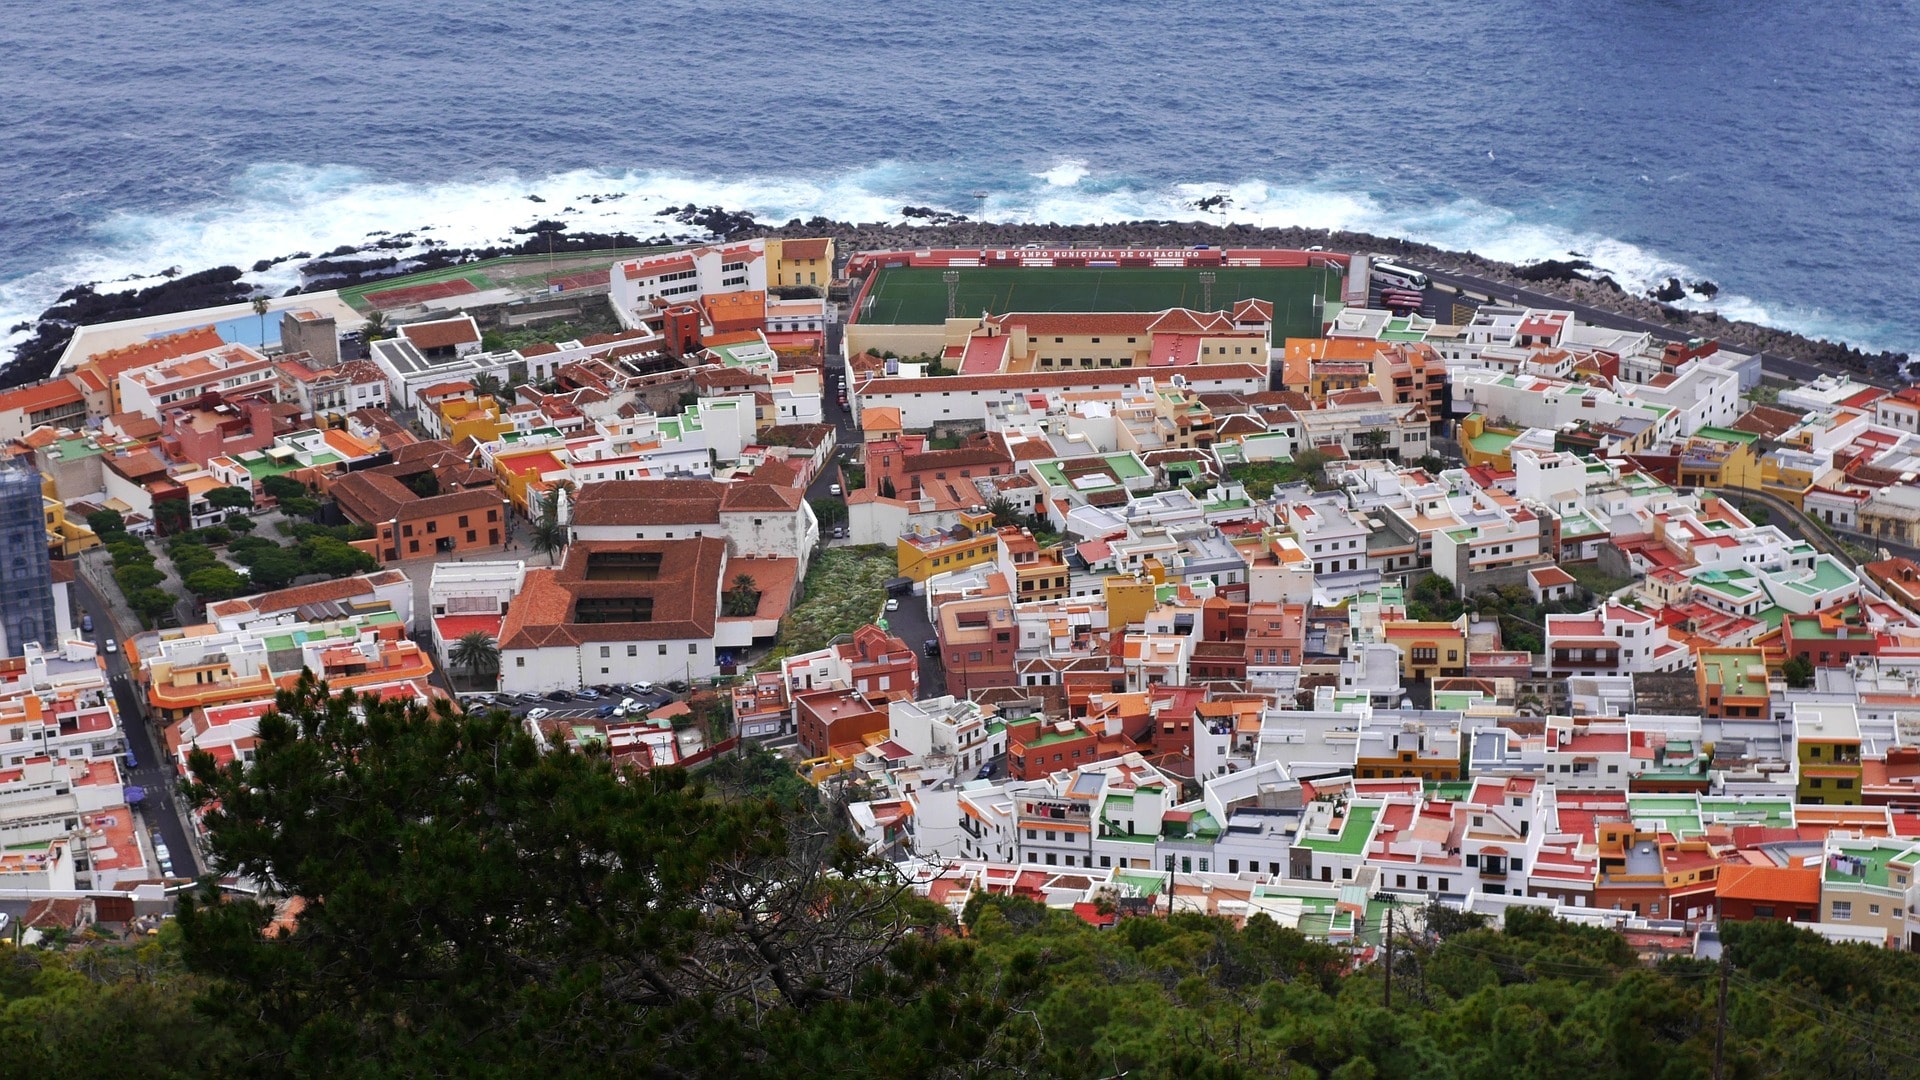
top-left (854, 267), bottom-right (1340, 340)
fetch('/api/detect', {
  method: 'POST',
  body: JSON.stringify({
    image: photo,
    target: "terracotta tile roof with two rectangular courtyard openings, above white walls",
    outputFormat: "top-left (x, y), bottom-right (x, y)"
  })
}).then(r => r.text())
top-left (499, 536), bottom-right (726, 650)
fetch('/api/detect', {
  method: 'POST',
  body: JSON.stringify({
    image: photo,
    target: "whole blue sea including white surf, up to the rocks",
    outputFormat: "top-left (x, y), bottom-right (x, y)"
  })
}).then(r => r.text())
top-left (0, 0), bottom-right (1920, 352)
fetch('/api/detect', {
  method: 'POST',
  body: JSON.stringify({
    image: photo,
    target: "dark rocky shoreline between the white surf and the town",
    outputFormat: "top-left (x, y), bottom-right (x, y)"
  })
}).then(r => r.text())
top-left (0, 204), bottom-right (1907, 388)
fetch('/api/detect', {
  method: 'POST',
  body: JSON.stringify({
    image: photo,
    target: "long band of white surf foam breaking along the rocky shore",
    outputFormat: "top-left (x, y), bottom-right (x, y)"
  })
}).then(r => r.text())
top-left (0, 160), bottom-right (1901, 357)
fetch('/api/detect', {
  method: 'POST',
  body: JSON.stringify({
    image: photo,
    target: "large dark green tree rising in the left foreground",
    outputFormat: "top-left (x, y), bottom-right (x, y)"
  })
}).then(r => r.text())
top-left (179, 678), bottom-right (944, 1076)
